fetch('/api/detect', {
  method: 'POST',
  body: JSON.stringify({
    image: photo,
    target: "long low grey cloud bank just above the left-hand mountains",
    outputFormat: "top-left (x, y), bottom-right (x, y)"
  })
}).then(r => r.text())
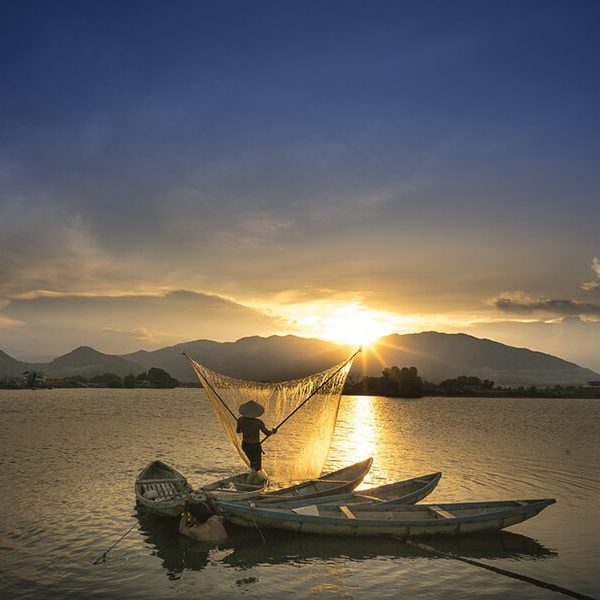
top-left (0, 290), bottom-right (284, 359)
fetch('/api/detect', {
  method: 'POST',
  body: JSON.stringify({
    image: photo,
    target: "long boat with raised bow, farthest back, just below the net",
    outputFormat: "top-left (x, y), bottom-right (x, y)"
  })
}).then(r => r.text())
top-left (209, 458), bottom-right (373, 504)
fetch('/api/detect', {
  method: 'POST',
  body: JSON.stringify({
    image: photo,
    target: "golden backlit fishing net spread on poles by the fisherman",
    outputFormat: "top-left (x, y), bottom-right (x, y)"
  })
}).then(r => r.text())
top-left (188, 356), bottom-right (353, 482)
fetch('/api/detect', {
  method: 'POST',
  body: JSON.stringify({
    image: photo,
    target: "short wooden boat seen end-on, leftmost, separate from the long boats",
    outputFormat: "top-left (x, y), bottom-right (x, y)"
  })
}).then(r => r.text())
top-left (134, 460), bottom-right (192, 517)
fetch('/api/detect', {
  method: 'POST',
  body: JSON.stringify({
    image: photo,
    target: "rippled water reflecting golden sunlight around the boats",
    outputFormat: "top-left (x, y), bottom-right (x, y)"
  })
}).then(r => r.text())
top-left (0, 389), bottom-right (600, 600)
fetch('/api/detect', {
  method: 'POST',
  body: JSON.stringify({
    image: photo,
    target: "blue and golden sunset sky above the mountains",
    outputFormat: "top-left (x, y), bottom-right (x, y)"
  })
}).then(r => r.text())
top-left (0, 0), bottom-right (600, 370)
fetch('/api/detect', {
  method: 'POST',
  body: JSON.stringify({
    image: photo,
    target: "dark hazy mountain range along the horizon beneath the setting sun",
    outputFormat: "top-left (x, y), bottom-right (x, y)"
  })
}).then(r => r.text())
top-left (0, 331), bottom-right (600, 385)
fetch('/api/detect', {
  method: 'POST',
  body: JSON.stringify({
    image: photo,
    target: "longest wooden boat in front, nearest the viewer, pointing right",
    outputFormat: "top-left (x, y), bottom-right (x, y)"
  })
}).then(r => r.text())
top-left (220, 499), bottom-right (555, 539)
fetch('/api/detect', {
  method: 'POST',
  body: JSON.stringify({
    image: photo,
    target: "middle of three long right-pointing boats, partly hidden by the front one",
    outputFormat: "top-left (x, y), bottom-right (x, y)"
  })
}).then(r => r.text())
top-left (255, 472), bottom-right (442, 510)
